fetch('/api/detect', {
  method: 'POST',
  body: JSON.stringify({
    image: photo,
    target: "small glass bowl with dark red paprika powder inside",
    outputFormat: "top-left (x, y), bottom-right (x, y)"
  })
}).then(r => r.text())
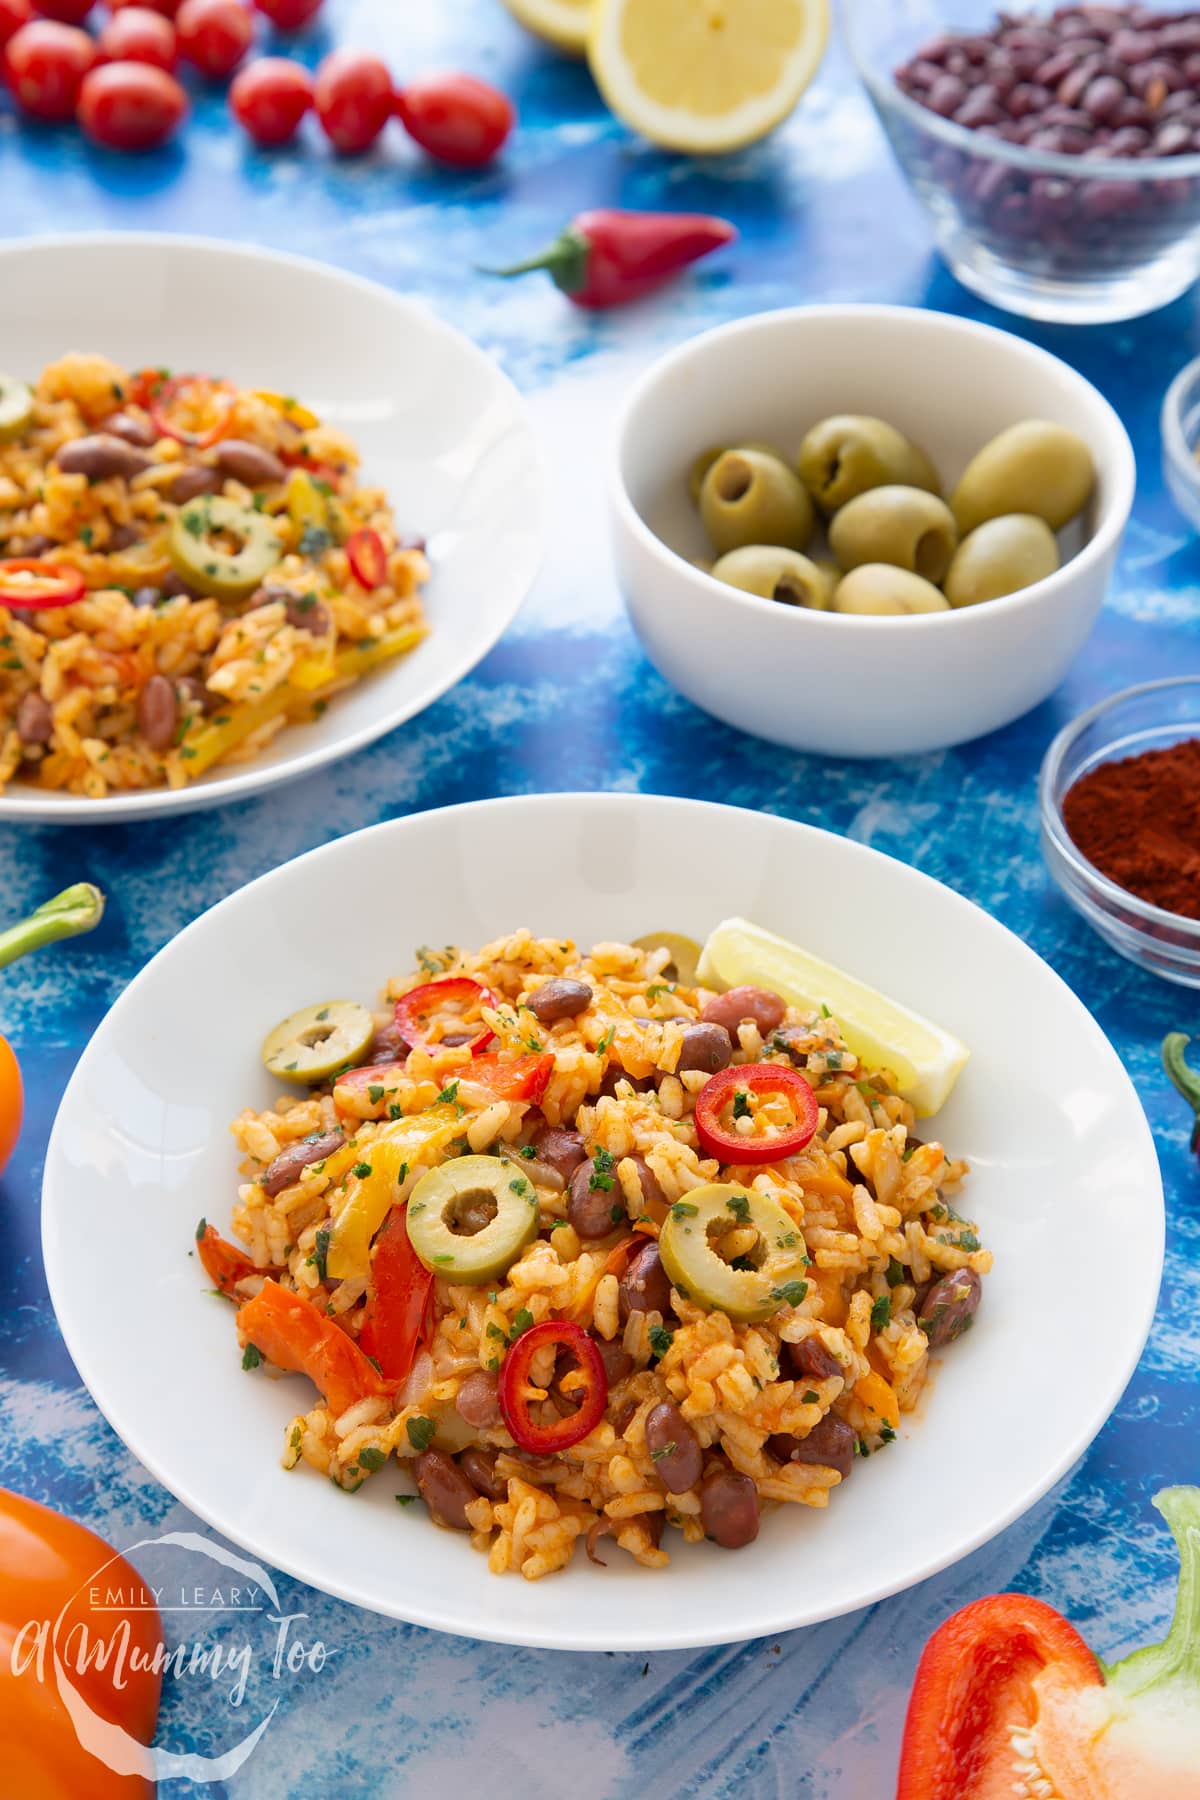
top-left (1040, 675), bottom-right (1200, 988)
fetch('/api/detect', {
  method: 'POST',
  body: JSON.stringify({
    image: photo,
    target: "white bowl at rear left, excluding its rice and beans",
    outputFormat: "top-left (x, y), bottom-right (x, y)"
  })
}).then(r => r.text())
top-left (0, 232), bottom-right (543, 824)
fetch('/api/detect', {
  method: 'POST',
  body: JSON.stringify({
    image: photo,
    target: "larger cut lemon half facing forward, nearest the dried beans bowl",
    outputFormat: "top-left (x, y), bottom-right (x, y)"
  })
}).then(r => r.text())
top-left (590, 0), bottom-right (829, 155)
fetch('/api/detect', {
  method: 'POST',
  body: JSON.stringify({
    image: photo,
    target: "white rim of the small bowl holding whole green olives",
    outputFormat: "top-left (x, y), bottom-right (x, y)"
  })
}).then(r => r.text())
top-left (608, 304), bottom-right (1137, 650)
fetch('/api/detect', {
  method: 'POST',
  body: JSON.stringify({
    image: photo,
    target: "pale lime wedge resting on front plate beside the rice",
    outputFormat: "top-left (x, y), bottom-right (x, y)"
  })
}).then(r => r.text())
top-left (698, 918), bottom-right (970, 1118)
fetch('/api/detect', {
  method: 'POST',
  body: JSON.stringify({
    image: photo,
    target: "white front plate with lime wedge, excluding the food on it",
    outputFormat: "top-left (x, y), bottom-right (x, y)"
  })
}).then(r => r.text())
top-left (43, 794), bottom-right (1162, 1651)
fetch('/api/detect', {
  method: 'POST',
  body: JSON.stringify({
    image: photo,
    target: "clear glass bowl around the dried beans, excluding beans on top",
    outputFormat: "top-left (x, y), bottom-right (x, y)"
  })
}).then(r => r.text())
top-left (842, 0), bottom-right (1200, 324)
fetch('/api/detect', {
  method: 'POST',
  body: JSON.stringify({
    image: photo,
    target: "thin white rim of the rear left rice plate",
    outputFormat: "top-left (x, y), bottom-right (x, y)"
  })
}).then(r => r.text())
top-left (0, 230), bottom-right (547, 824)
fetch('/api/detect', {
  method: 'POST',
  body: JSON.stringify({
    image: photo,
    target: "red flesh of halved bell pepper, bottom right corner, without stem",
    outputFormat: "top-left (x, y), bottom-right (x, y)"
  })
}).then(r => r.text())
top-left (896, 1593), bottom-right (1103, 1800)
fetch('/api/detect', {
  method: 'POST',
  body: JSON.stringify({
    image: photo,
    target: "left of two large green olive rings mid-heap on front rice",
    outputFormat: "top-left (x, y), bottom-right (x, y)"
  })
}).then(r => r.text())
top-left (405, 1156), bottom-right (538, 1287)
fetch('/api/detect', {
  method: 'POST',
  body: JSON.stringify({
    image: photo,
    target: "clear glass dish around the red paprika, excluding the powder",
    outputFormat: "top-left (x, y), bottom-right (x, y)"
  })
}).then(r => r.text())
top-left (1038, 675), bottom-right (1200, 988)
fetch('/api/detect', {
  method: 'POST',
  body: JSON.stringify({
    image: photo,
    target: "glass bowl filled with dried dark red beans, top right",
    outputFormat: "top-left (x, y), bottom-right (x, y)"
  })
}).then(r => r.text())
top-left (842, 0), bottom-right (1200, 324)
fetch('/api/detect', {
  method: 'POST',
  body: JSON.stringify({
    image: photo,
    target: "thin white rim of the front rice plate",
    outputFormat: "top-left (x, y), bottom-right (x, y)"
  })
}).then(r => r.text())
top-left (41, 794), bottom-right (1166, 1652)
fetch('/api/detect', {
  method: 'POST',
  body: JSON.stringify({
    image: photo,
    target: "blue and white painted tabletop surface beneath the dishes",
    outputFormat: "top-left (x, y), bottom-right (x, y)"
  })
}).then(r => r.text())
top-left (0, 0), bottom-right (1200, 1800)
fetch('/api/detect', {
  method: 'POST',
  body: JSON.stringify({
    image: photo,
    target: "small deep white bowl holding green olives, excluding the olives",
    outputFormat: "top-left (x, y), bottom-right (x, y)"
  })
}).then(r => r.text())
top-left (610, 306), bottom-right (1135, 756)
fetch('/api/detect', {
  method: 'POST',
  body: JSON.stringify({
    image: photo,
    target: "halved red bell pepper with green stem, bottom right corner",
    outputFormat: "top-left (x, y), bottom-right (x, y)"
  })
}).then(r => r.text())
top-left (896, 1487), bottom-right (1200, 1800)
